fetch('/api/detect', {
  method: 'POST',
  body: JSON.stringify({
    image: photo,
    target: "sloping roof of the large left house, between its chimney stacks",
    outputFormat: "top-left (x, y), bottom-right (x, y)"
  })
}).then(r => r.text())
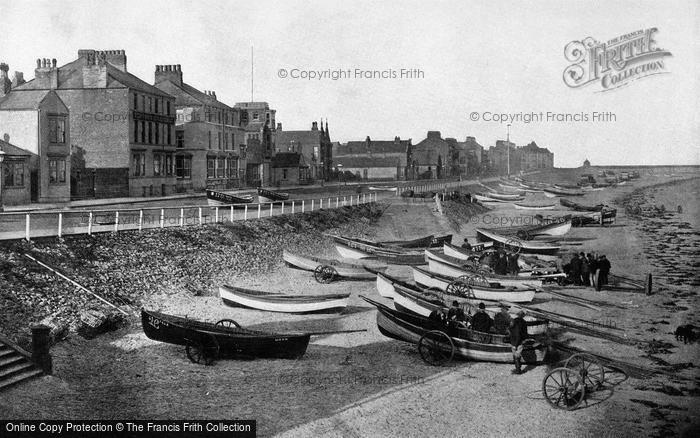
top-left (14, 58), bottom-right (172, 97)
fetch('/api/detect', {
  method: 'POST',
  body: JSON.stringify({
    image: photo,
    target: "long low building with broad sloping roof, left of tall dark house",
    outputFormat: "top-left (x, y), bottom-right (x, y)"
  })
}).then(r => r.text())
top-left (333, 136), bottom-right (413, 180)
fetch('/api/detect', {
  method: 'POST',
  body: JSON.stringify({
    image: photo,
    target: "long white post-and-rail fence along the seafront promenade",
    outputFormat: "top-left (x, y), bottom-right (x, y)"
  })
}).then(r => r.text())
top-left (0, 181), bottom-right (476, 240)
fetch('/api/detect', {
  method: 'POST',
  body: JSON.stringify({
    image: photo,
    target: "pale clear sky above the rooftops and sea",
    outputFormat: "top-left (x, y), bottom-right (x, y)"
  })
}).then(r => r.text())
top-left (0, 0), bottom-right (700, 167)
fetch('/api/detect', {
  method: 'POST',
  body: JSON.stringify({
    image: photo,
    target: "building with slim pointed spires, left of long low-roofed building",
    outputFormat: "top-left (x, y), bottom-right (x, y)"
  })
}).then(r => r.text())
top-left (275, 121), bottom-right (333, 180)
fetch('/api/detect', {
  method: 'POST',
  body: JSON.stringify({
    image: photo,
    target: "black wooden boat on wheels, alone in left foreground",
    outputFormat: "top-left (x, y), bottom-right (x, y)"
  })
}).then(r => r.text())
top-left (141, 309), bottom-right (311, 362)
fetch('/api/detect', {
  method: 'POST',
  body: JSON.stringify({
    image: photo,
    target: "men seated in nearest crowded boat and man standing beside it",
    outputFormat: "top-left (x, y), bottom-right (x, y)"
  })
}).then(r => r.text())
top-left (429, 301), bottom-right (528, 374)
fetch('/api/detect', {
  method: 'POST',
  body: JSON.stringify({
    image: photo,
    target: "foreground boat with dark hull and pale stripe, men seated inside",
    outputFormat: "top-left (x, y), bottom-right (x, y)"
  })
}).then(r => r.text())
top-left (363, 297), bottom-right (547, 363)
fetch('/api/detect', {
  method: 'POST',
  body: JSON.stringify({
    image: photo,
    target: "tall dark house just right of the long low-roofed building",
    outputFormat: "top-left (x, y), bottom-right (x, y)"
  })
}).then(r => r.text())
top-left (409, 131), bottom-right (452, 179)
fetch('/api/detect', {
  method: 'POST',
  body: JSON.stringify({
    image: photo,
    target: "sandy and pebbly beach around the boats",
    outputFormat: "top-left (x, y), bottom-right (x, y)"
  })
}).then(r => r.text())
top-left (0, 169), bottom-right (700, 437)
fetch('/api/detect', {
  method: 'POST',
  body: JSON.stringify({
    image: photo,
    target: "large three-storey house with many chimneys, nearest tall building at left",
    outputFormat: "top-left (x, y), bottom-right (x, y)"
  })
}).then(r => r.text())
top-left (11, 50), bottom-right (176, 199)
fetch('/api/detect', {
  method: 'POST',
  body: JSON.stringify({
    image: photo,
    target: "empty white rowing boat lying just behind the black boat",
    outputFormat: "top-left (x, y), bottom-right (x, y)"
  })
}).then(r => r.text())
top-left (219, 285), bottom-right (350, 313)
